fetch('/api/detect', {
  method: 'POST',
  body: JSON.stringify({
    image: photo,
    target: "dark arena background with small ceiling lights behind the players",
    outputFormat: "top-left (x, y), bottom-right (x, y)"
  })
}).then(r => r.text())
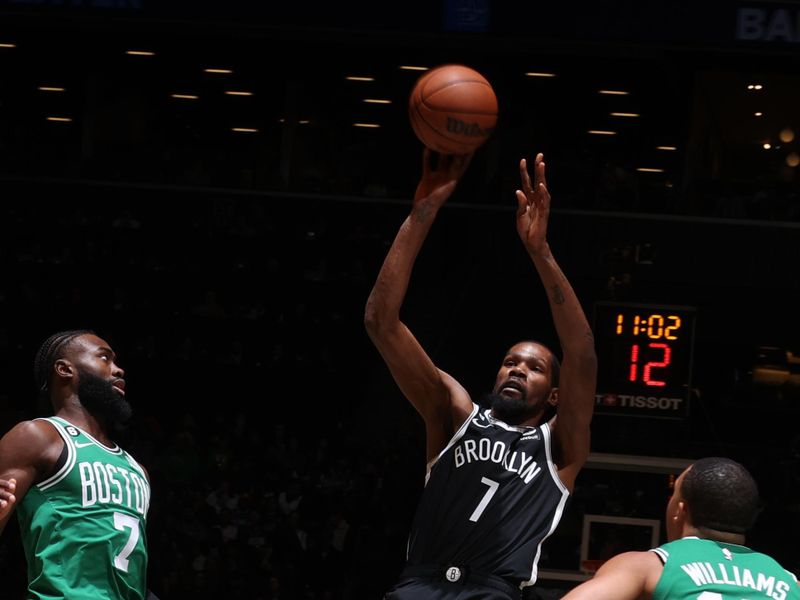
top-left (0, 0), bottom-right (800, 600)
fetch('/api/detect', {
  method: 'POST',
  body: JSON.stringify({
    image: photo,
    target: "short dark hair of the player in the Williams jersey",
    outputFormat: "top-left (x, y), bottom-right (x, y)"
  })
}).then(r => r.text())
top-left (681, 456), bottom-right (759, 534)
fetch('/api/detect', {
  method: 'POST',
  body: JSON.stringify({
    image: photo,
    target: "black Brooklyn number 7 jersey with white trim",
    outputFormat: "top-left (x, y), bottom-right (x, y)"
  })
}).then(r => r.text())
top-left (407, 405), bottom-right (569, 586)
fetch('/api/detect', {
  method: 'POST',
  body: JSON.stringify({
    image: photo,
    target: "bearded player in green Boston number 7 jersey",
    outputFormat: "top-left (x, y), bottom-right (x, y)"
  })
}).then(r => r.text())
top-left (0, 329), bottom-right (152, 600)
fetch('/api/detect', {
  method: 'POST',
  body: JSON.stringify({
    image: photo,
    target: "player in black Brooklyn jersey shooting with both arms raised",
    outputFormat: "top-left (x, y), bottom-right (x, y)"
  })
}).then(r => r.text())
top-left (365, 149), bottom-right (597, 600)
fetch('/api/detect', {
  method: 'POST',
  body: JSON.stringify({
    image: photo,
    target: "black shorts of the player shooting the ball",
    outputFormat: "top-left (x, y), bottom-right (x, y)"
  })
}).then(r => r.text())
top-left (384, 567), bottom-right (522, 600)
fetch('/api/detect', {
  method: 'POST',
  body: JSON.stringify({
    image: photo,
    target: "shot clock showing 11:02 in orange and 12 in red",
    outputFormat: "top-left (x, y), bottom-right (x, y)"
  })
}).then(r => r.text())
top-left (593, 302), bottom-right (696, 419)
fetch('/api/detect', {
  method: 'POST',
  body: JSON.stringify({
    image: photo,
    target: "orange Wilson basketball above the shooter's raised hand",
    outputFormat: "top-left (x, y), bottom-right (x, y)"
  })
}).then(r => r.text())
top-left (408, 64), bottom-right (497, 154)
